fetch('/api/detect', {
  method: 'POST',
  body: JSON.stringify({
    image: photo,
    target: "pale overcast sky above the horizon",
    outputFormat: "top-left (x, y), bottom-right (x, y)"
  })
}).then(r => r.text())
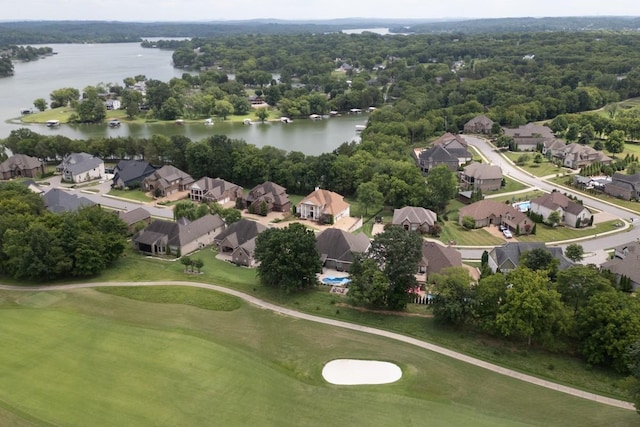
top-left (5, 0), bottom-right (640, 21)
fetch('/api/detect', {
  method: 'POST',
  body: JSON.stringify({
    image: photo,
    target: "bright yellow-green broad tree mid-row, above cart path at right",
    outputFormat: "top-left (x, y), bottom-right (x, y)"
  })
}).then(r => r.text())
top-left (496, 267), bottom-right (567, 345)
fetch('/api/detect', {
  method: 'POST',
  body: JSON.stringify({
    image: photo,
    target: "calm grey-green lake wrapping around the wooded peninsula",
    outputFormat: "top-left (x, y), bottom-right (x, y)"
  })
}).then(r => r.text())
top-left (0, 43), bottom-right (367, 154)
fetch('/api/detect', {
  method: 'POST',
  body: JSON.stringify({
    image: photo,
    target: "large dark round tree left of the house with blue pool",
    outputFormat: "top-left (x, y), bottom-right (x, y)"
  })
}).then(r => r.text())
top-left (255, 223), bottom-right (322, 293)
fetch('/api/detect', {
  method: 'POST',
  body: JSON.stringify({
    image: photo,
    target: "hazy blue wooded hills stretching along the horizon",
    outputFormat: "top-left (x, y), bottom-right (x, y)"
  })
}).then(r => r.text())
top-left (0, 17), bottom-right (640, 46)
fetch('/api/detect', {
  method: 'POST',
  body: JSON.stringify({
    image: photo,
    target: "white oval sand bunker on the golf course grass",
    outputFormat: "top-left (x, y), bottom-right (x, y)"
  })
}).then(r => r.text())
top-left (322, 359), bottom-right (402, 385)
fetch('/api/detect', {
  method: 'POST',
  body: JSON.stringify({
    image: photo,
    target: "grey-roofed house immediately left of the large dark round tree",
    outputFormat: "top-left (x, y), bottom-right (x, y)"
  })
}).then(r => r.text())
top-left (215, 218), bottom-right (267, 267)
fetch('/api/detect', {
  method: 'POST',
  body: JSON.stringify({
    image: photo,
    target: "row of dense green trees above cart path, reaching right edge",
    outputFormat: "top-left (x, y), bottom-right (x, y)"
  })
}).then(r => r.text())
top-left (431, 249), bottom-right (640, 372)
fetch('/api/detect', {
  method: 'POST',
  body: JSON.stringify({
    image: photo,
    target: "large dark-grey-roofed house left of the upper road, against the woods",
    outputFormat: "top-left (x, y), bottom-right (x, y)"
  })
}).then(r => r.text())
top-left (414, 133), bottom-right (473, 173)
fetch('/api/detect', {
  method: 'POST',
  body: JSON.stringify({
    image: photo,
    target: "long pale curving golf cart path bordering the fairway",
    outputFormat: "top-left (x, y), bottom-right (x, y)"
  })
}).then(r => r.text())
top-left (0, 281), bottom-right (635, 410)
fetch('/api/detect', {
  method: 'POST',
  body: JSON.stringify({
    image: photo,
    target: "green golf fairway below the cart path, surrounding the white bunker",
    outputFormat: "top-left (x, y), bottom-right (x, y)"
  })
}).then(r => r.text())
top-left (0, 288), bottom-right (638, 426)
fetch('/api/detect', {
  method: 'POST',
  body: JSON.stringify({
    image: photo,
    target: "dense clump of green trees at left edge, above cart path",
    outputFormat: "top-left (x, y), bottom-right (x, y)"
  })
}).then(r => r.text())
top-left (0, 183), bottom-right (127, 280)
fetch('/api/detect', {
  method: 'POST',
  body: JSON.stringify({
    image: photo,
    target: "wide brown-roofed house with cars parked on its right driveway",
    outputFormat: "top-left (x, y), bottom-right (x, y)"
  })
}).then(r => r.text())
top-left (458, 199), bottom-right (533, 234)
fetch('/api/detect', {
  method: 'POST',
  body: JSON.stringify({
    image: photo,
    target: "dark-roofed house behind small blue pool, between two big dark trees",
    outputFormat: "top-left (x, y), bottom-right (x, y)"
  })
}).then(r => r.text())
top-left (316, 228), bottom-right (371, 271)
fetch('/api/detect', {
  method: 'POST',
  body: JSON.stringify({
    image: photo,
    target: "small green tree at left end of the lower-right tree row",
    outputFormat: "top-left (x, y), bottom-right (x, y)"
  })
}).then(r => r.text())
top-left (429, 267), bottom-right (473, 325)
